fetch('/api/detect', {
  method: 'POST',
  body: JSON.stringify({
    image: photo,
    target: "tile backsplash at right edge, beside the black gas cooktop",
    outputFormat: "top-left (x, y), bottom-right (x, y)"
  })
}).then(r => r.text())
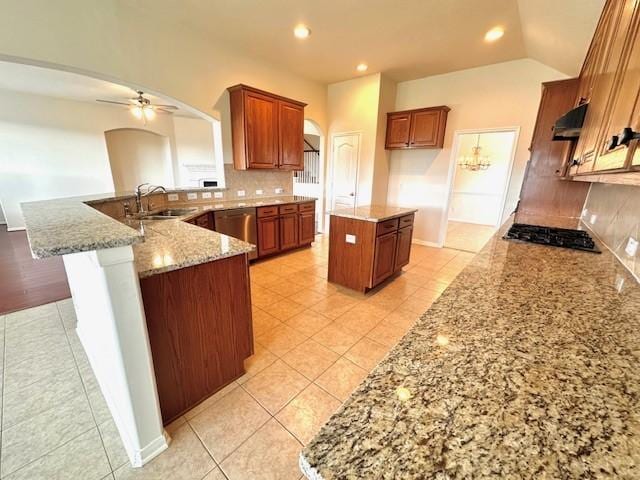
top-left (582, 183), bottom-right (640, 278)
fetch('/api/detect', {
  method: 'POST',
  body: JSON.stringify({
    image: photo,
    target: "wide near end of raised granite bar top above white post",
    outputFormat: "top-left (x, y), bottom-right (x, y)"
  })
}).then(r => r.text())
top-left (21, 197), bottom-right (142, 258)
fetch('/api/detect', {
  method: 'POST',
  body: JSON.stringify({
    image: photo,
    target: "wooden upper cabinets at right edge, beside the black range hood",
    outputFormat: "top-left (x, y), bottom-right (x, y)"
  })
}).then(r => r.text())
top-left (570, 0), bottom-right (640, 184)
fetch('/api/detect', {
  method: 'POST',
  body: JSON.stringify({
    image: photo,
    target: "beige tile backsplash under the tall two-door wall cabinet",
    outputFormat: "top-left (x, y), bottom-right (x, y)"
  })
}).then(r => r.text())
top-left (224, 164), bottom-right (293, 200)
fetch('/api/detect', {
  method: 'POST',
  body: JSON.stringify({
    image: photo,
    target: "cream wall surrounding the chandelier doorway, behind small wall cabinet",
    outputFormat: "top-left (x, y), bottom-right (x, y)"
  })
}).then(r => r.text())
top-left (387, 59), bottom-right (566, 244)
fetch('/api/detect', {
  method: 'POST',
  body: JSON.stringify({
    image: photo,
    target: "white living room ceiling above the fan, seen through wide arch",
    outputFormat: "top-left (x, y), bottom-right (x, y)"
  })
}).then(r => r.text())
top-left (0, 62), bottom-right (199, 117)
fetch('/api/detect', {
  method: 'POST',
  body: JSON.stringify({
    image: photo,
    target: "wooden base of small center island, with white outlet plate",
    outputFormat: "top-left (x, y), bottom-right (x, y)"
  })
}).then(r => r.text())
top-left (328, 213), bottom-right (414, 292)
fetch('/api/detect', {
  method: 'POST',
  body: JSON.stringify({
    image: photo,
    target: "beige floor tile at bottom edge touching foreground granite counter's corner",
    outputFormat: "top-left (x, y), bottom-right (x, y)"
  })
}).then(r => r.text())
top-left (221, 419), bottom-right (302, 480)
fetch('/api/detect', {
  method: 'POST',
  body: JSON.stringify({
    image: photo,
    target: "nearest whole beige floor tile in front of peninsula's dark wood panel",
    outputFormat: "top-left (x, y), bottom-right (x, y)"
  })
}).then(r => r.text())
top-left (189, 388), bottom-right (270, 462)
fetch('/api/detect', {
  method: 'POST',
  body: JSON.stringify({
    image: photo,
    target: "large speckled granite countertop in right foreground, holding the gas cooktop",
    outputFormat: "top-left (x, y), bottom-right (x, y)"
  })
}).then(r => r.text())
top-left (300, 218), bottom-right (640, 480)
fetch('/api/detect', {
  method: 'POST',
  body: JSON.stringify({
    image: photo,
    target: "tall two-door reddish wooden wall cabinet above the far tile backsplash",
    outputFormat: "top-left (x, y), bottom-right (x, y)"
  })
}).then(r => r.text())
top-left (229, 85), bottom-right (306, 170)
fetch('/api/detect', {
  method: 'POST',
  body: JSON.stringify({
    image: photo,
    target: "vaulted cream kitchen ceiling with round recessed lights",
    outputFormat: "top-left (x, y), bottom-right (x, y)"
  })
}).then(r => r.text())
top-left (121, 0), bottom-right (604, 83)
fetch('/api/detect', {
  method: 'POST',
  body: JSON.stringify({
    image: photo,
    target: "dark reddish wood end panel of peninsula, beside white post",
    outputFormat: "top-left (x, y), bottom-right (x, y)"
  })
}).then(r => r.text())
top-left (140, 255), bottom-right (253, 424)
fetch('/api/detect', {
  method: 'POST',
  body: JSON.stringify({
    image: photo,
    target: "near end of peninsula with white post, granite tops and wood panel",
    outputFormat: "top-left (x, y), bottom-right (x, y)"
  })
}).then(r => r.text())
top-left (22, 195), bottom-right (255, 466)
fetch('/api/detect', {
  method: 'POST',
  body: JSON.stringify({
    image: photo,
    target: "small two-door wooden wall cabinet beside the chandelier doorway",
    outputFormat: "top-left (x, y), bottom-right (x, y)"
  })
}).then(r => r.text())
top-left (385, 106), bottom-right (450, 150)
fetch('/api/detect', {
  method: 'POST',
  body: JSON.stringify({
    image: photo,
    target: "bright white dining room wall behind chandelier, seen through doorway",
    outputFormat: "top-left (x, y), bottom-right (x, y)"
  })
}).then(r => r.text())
top-left (449, 131), bottom-right (517, 226)
